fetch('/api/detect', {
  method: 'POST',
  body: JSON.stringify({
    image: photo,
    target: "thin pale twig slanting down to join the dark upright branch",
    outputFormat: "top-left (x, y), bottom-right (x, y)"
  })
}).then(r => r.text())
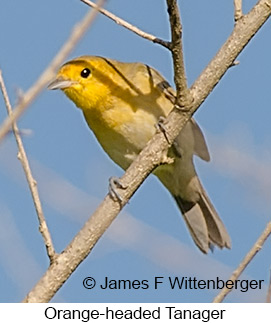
top-left (80, 0), bottom-right (170, 48)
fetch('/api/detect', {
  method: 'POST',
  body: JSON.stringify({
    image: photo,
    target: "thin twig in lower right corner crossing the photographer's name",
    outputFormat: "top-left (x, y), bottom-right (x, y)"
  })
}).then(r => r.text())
top-left (213, 222), bottom-right (271, 303)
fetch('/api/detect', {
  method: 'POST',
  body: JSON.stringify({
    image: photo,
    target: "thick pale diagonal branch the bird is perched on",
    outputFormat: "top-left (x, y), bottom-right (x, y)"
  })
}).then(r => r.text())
top-left (24, 0), bottom-right (271, 302)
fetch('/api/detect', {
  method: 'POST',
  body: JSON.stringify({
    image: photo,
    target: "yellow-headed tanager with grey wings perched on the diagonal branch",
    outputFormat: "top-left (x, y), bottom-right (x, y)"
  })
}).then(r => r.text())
top-left (48, 56), bottom-right (231, 253)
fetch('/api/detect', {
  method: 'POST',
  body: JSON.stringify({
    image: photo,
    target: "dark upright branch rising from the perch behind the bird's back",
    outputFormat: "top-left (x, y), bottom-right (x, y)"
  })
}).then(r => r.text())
top-left (167, 0), bottom-right (192, 109)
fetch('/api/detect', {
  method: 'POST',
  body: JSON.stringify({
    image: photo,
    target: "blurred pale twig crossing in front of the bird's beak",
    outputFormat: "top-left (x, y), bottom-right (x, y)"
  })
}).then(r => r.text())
top-left (0, 0), bottom-right (105, 141)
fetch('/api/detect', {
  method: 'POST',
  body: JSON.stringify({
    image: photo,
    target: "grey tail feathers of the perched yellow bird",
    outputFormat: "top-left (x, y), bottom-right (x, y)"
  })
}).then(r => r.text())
top-left (174, 187), bottom-right (231, 253)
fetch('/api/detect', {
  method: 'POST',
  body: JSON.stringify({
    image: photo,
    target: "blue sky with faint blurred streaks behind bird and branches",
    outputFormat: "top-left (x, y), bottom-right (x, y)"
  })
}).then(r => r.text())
top-left (0, 0), bottom-right (271, 302)
